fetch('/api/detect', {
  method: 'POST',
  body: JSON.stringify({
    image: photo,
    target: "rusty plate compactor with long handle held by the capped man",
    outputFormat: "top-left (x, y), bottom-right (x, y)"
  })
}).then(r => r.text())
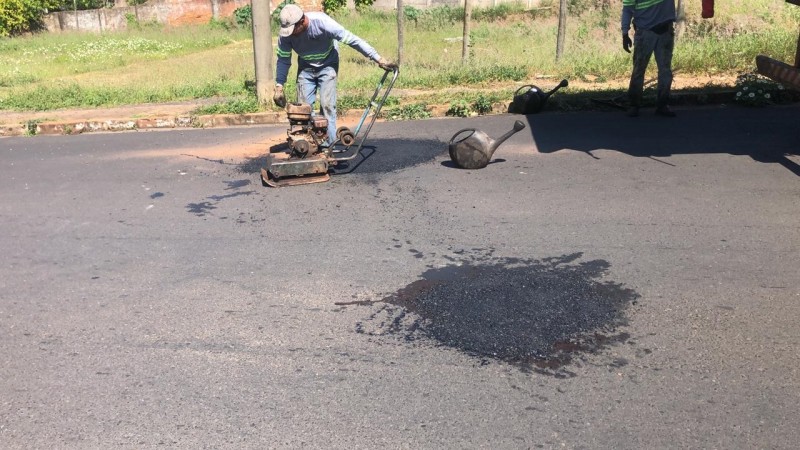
top-left (261, 68), bottom-right (399, 187)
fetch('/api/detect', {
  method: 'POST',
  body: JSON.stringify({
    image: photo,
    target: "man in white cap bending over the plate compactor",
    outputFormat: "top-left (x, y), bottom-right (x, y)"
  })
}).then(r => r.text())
top-left (272, 3), bottom-right (397, 145)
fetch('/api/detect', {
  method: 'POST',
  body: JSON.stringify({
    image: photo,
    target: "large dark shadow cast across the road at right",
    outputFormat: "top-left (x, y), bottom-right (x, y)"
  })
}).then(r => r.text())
top-left (514, 106), bottom-right (800, 176)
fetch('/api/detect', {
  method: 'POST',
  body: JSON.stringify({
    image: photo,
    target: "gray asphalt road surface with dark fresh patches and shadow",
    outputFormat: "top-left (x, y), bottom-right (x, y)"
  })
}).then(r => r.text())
top-left (0, 106), bottom-right (800, 449)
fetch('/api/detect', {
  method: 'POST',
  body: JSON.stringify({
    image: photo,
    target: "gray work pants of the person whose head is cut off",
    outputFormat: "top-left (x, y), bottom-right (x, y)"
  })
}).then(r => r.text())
top-left (628, 27), bottom-right (675, 107)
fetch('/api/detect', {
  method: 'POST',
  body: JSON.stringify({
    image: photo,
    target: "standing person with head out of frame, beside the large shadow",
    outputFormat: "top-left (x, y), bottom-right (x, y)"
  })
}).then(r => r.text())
top-left (622, 0), bottom-right (676, 117)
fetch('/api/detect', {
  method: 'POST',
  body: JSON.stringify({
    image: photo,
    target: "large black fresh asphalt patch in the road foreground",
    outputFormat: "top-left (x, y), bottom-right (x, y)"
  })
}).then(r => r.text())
top-left (348, 253), bottom-right (639, 377)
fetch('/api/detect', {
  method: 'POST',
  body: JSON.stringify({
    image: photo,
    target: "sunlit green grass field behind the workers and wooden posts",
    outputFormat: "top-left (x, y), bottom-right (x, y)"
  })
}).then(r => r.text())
top-left (0, 0), bottom-right (800, 117)
